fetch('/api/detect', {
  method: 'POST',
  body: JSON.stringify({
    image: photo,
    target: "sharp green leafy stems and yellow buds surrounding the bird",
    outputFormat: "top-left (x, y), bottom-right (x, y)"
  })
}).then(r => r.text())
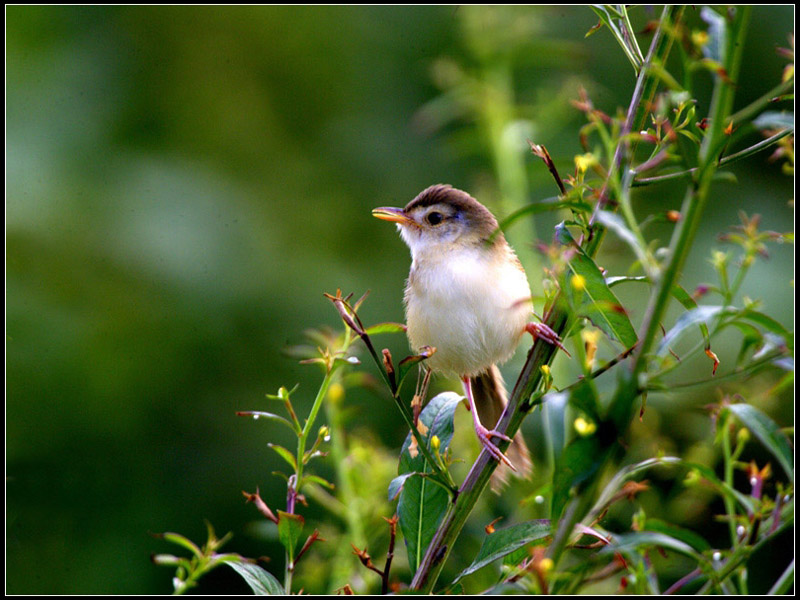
top-left (152, 6), bottom-right (794, 594)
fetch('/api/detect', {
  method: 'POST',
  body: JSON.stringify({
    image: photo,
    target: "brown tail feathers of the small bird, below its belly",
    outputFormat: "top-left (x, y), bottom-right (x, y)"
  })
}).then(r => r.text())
top-left (470, 365), bottom-right (532, 493)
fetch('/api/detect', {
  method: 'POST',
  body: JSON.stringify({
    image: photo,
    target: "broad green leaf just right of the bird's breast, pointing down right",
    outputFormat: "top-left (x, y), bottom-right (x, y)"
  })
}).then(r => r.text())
top-left (556, 223), bottom-right (637, 348)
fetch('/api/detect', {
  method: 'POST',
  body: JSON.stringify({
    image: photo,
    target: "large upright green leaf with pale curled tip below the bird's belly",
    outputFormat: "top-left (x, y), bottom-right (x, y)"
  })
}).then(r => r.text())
top-left (390, 392), bottom-right (462, 571)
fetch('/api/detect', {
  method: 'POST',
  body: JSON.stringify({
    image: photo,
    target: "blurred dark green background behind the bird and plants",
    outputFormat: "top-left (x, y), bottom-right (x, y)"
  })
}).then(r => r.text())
top-left (6, 6), bottom-right (793, 594)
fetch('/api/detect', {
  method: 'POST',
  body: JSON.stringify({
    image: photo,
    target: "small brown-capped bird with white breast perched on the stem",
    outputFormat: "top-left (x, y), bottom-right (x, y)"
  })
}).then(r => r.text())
top-left (372, 185), bottom-right (563, 489)
